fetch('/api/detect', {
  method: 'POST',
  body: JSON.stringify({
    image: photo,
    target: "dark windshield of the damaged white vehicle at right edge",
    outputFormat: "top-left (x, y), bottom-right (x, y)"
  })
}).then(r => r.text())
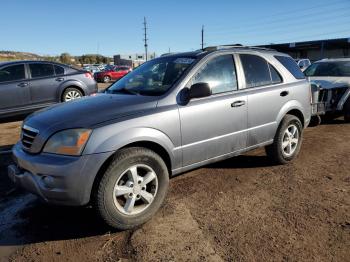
top-left (304, 61), bottom-right (350, 76)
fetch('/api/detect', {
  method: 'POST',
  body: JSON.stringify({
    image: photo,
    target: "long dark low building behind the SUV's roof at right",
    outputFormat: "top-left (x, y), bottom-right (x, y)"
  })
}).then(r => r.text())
top-left (259, 38), bottom-right (350, 61)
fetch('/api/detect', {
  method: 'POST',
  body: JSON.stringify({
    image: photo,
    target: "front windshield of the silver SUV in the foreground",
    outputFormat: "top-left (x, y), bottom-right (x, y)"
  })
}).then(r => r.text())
top-left (105, 57), bottom-right (195, 96)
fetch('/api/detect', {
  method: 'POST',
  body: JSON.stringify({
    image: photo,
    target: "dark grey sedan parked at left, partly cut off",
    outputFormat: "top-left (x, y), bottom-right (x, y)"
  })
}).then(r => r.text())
top-left (0, 61), bottom-right (97, 118)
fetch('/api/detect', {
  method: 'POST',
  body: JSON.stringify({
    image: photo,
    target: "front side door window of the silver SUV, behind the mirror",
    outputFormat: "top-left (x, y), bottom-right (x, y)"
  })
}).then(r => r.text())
top-left (192, 55), bottom-right (237, 94)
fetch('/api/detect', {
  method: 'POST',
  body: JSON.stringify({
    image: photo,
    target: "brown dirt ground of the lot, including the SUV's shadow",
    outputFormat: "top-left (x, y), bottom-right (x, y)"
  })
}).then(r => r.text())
top-left (0, 103), bottom-right (350, 261)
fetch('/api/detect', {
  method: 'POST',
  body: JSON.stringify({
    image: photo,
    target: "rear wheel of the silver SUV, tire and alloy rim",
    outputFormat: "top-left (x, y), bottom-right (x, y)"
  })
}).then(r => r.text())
top-left (265, 115), bottom-right (303, 165)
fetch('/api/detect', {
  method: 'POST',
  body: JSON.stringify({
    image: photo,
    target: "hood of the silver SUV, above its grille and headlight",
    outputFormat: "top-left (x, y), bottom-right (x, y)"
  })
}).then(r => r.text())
top-left (24, 94), bottom-right (157, 135)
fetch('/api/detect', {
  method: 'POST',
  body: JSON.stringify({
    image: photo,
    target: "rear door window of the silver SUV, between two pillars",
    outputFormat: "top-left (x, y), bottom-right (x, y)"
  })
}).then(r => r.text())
top-left (240, 54), bottom-right (272, 88)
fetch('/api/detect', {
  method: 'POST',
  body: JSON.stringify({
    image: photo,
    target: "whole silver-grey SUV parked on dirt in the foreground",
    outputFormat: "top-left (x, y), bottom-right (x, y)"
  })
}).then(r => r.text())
top-left (8, 47), bottom-right (311, 229)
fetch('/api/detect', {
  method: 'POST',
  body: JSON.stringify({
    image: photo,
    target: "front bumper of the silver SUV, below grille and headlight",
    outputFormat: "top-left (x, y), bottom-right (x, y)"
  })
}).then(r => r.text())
top-left (8, 144), bottom-right (112, 206)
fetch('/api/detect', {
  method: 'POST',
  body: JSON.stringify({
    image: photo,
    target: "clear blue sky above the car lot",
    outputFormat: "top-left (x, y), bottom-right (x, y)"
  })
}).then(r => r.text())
top-left (0, 0), bottom-right (350, 56)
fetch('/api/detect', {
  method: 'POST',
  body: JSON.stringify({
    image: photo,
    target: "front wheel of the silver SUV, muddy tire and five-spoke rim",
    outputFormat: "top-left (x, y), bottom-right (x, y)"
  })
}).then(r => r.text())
top-left (94, 147), bottom-right (169, 230)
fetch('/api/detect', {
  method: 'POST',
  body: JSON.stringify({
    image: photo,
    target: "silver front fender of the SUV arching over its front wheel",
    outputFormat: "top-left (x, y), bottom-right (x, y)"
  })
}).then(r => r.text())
top-left (83, 127), bottom-right (176, 167)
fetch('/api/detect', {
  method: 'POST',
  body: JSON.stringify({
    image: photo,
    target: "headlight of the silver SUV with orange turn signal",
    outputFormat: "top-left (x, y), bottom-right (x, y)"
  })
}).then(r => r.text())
top-left (44, 129), bottom-right (91, 156)
